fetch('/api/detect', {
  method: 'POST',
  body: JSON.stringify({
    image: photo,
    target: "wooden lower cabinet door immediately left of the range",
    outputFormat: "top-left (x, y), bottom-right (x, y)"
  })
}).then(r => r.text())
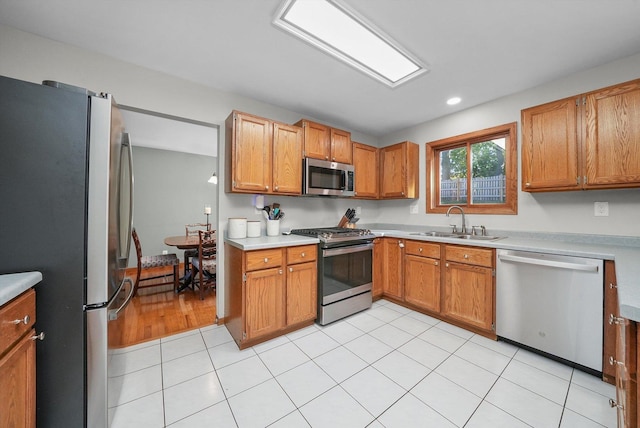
top-left (287, 262), bottom-right (318, 325)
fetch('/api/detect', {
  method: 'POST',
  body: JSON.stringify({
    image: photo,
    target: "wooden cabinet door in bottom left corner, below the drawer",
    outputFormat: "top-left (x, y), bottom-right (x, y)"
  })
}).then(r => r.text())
top-left (0, 330), bottom-right (36, 428)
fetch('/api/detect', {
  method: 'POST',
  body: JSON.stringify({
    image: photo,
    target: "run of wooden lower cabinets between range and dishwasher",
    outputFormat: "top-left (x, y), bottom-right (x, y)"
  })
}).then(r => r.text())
top-left (374, 238), bottom-right (496, 339)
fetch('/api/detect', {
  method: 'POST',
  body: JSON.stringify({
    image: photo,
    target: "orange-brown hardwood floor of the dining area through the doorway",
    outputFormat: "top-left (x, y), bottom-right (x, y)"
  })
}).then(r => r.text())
top-left (109, 268), bottom-right (216, 348)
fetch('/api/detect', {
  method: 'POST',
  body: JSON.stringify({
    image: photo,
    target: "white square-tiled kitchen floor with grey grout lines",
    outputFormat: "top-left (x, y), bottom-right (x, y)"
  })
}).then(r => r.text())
top-left (109, 300), bottom-right (616, 428)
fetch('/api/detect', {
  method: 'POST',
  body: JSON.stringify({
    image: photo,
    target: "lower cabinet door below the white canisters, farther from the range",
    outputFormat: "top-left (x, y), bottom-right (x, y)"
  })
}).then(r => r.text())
top-left (245, 268), bottom-right (285, 340)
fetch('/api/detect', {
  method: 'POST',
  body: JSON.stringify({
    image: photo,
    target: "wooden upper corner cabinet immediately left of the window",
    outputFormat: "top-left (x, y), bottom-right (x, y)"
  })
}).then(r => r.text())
top-left (380, 141), bottom-right (420, 199)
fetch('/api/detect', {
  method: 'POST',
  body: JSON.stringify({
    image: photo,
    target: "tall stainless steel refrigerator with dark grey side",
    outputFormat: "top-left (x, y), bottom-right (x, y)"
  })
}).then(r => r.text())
top-left (0, 76), bottom-right (133, 428)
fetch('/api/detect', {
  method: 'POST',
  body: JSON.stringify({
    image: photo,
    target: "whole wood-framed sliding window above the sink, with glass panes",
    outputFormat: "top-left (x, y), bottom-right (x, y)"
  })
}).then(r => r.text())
top-left (426, 122), bottom-right (518, 214)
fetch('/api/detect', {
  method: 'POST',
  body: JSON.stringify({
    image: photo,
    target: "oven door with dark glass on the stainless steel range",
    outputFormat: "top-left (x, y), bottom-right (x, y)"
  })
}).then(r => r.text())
top-left (321, 249), bottom-right (373, 304)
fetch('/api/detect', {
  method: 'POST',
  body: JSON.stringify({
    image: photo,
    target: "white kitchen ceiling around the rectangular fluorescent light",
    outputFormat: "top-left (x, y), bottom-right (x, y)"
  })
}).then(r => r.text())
top-left (0, 0), bottom-right (640, 136)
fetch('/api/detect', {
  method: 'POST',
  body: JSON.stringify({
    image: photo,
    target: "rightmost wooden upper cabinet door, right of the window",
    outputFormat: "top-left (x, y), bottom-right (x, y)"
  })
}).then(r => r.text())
top-left (584, 80), bottom-right (640, 188)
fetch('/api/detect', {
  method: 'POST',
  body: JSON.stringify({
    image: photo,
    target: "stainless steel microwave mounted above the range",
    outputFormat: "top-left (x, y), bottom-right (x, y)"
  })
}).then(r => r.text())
top-left (302, 158), bottom-right (355, 196)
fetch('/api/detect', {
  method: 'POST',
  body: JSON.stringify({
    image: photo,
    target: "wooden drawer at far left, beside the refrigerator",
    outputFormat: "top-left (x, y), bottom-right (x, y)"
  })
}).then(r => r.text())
top-left (0, 289), bottom-right (36, 355)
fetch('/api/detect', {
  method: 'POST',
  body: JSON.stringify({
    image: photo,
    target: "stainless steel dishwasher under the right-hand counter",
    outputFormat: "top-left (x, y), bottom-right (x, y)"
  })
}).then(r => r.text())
top-left (496, 250), bottom-right (603, 372)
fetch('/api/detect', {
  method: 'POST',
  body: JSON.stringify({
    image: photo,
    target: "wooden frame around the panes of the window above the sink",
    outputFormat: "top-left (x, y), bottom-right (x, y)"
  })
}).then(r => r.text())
top-left (425, 122), bottom-right (518, 214)
